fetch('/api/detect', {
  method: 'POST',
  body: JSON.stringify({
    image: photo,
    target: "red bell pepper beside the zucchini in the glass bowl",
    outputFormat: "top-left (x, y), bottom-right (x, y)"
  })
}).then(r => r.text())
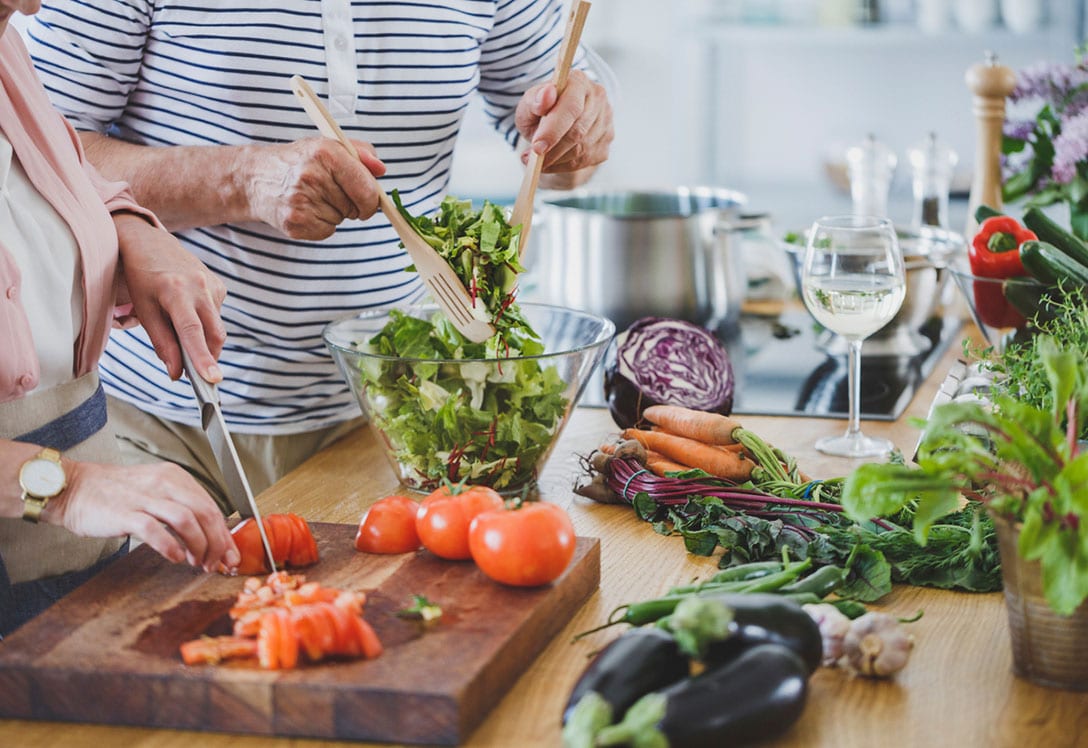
top-left (967, 215), bottom-right (1038, 328)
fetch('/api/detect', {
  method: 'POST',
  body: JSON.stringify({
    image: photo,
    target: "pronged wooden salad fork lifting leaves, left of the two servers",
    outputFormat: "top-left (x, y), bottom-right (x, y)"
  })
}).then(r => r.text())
top-left (290, 75), bottom-right (495, 342)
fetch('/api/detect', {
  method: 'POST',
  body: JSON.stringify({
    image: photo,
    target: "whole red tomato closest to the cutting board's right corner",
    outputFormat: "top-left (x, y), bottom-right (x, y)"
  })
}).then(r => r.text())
top-left (469, 501), bottom-right (574, 587)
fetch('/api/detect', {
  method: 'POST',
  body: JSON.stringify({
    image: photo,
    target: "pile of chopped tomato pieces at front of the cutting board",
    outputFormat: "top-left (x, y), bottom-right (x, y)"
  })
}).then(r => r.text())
top-left (181, 572), bottom-right (382, 670)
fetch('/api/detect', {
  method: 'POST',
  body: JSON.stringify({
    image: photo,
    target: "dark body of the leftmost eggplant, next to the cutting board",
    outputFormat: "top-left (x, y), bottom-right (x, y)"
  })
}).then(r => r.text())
top-left (562, 626), bottom-right (690, 724)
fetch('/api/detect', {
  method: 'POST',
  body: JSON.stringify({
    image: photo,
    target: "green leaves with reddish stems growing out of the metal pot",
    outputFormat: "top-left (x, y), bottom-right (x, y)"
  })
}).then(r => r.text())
top-left (843, 332), bottom-right (1088, 615)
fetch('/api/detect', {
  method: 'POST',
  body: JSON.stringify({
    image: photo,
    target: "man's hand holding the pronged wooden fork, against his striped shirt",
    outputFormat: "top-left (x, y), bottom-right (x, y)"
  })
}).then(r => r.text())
top-left (243, 138), bottom-right (385, 240)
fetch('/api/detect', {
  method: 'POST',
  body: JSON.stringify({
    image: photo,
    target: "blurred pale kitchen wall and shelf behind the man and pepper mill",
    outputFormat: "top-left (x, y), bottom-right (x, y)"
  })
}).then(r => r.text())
top-left (450, 0), bottom-right (1088, 228)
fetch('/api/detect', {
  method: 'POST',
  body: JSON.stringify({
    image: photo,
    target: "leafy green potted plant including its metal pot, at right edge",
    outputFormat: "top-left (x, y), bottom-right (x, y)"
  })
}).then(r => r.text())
top-left (842, 290), bottom-right (1088, 690)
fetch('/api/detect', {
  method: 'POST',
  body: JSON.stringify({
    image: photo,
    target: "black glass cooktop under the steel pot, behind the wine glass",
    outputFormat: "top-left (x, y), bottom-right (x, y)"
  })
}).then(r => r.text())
top-left (580, 309), bottom-right (962, 421)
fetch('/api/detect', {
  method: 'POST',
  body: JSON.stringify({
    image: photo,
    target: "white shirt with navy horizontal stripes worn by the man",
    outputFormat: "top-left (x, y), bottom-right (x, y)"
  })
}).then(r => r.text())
top-left (24, 0), bottom-right (564, 434)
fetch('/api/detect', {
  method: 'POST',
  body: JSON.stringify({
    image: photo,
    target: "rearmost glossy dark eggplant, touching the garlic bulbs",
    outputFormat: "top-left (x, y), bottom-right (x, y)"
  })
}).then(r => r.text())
top-left (704, 593), bottom-right (824, 675)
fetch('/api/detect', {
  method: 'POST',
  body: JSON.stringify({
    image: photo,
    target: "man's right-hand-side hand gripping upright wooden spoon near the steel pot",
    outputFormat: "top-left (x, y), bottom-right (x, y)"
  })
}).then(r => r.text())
top-left (515, 71), bottom-right (614, 186)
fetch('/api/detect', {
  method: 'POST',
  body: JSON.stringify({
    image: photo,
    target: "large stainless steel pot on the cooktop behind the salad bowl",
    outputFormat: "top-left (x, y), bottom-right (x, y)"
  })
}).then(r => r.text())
top-left (526, 187), bottom-right (745, 329)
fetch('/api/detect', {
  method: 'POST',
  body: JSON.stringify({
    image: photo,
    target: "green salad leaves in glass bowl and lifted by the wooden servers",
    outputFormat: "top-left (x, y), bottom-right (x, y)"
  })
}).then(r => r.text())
top-left (359, 192), bottom-right (569, 490)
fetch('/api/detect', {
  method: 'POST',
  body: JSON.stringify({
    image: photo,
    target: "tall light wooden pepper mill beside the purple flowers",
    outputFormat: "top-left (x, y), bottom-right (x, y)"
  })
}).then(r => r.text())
top-left (964, 52), bottom-right (1016, 240)
